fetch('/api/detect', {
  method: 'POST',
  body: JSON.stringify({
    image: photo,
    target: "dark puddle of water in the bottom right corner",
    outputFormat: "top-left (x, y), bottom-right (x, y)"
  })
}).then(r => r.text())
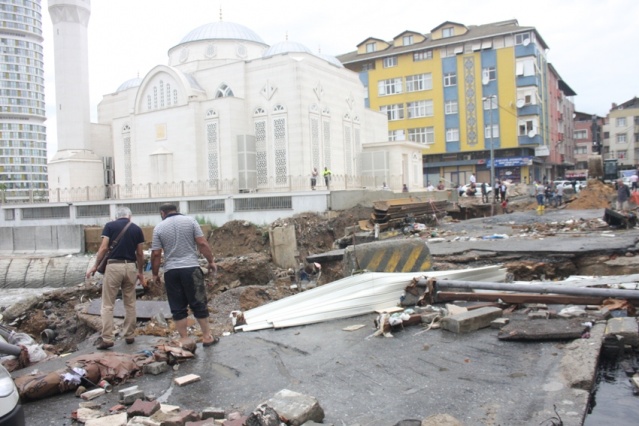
top-left (584, 354), bottom-right (639, 426)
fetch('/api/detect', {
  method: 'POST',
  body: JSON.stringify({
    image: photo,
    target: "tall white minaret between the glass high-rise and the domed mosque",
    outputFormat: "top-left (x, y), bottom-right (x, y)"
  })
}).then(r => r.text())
top-left (49, 0), bottom-right (104, 195)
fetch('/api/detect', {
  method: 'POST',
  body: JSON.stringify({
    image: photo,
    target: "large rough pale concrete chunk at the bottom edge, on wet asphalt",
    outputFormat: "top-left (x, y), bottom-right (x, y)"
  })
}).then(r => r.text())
top-left (265, 389), bottom-right (324, 426)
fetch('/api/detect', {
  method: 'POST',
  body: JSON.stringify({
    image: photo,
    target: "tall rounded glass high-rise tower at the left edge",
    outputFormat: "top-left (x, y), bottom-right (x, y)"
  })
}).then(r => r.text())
top-left (0, 0), bottom-right (48, 200)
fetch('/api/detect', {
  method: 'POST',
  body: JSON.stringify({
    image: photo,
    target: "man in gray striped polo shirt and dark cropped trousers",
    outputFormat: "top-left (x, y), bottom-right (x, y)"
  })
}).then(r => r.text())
top-left (151, 204), bottom-right (218, 346)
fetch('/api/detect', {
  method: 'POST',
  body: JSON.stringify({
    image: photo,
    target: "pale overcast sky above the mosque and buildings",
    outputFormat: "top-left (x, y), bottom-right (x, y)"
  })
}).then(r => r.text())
top-left (42, 0), bottom-right (639, 158)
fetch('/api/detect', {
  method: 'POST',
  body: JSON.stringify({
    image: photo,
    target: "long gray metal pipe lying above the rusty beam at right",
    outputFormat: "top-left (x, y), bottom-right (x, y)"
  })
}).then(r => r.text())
top-left (435, 280), bottom-right (639, 300)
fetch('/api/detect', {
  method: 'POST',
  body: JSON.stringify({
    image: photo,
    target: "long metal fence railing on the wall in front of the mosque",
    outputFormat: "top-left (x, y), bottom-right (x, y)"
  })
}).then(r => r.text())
top-left (0, 172), bottom-right (405, 204)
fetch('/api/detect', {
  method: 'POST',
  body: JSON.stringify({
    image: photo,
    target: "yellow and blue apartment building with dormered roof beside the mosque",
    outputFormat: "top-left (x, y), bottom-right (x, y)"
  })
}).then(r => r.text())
top-left (338, 20), bottom-right (574, 186)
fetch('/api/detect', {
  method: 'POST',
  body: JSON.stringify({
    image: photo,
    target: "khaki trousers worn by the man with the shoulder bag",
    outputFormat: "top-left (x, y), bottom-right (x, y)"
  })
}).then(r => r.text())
top-left (100, 262), bottom-right (138, 342)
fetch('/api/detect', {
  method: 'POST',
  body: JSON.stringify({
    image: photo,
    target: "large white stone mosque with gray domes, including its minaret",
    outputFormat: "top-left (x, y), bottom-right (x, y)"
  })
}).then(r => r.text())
top-left (49, 0), bottom-right (423, 197)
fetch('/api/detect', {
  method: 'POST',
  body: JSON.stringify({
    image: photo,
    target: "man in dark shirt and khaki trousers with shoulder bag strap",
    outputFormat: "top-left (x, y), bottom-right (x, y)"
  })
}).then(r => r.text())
top-left (86, 206), bottom-right (146, 349)
